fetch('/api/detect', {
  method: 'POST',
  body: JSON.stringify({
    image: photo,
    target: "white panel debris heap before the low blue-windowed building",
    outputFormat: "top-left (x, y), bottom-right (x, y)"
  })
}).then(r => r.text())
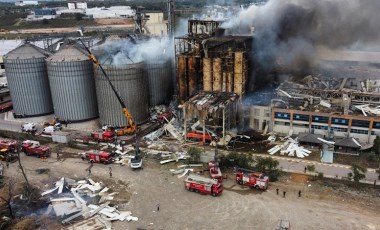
top-left (268, 137), bottom-right (311, 158)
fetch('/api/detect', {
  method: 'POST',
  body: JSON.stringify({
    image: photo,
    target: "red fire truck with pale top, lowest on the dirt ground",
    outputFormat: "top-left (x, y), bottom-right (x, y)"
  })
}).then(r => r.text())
top-left (184, 174), bottom-right (223, 197)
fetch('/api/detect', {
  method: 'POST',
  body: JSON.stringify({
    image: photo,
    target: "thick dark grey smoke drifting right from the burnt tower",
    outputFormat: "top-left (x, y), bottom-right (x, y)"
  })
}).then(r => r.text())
top-left (223, 0), bottom-right (380, 71)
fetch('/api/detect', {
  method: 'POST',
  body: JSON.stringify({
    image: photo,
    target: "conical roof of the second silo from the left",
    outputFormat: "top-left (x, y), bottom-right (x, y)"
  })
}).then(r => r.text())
top-left (46, 45), bottom-right (89, 62)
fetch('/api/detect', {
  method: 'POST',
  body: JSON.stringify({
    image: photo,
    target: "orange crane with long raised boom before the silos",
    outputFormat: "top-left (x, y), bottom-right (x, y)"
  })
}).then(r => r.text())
top-left (79, 39), bottom-right (137, 136)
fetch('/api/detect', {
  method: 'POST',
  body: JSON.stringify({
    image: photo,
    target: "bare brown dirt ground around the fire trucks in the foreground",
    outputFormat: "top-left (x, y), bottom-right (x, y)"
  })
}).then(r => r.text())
top-left (0, 144), bottom-right (380, 230)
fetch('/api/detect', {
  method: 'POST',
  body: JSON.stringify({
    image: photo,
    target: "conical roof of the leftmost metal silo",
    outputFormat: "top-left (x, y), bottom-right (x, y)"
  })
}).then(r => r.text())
top-left (4, 43), bottom-right (49, 60)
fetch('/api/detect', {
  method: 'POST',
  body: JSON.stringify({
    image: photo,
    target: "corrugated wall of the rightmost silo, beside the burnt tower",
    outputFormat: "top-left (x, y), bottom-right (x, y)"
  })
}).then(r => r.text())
top-left (145, 60), bottom-right (173, 106)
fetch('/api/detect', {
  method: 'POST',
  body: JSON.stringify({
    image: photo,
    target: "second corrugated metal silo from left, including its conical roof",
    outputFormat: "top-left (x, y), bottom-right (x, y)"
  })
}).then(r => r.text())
top-left (46, 45), bottom-right (98, 121)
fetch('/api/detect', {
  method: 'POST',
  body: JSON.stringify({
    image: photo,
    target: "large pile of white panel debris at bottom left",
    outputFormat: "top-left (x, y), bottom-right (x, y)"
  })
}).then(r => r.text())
top-left (41, 177), bottom-right (138, 229)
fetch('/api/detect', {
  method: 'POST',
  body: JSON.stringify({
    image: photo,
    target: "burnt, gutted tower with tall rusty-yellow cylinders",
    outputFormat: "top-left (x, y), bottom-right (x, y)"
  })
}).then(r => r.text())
top-left (175, 20), bottom-right (253, 142)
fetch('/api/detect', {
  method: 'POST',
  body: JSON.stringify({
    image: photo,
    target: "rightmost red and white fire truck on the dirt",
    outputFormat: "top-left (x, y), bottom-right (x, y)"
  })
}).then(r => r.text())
top-left (236, 168), bottom-right (269, 190)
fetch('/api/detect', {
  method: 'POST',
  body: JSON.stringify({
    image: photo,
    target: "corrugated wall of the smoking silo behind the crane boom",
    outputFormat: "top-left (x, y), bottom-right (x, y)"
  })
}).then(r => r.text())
top-left (94, 62), bottom-right (149, 127)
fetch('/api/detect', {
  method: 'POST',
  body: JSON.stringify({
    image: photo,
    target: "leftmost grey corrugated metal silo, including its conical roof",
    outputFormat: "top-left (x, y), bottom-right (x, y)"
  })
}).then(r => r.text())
top-left (4, 44), bottom-right (53, 117)
